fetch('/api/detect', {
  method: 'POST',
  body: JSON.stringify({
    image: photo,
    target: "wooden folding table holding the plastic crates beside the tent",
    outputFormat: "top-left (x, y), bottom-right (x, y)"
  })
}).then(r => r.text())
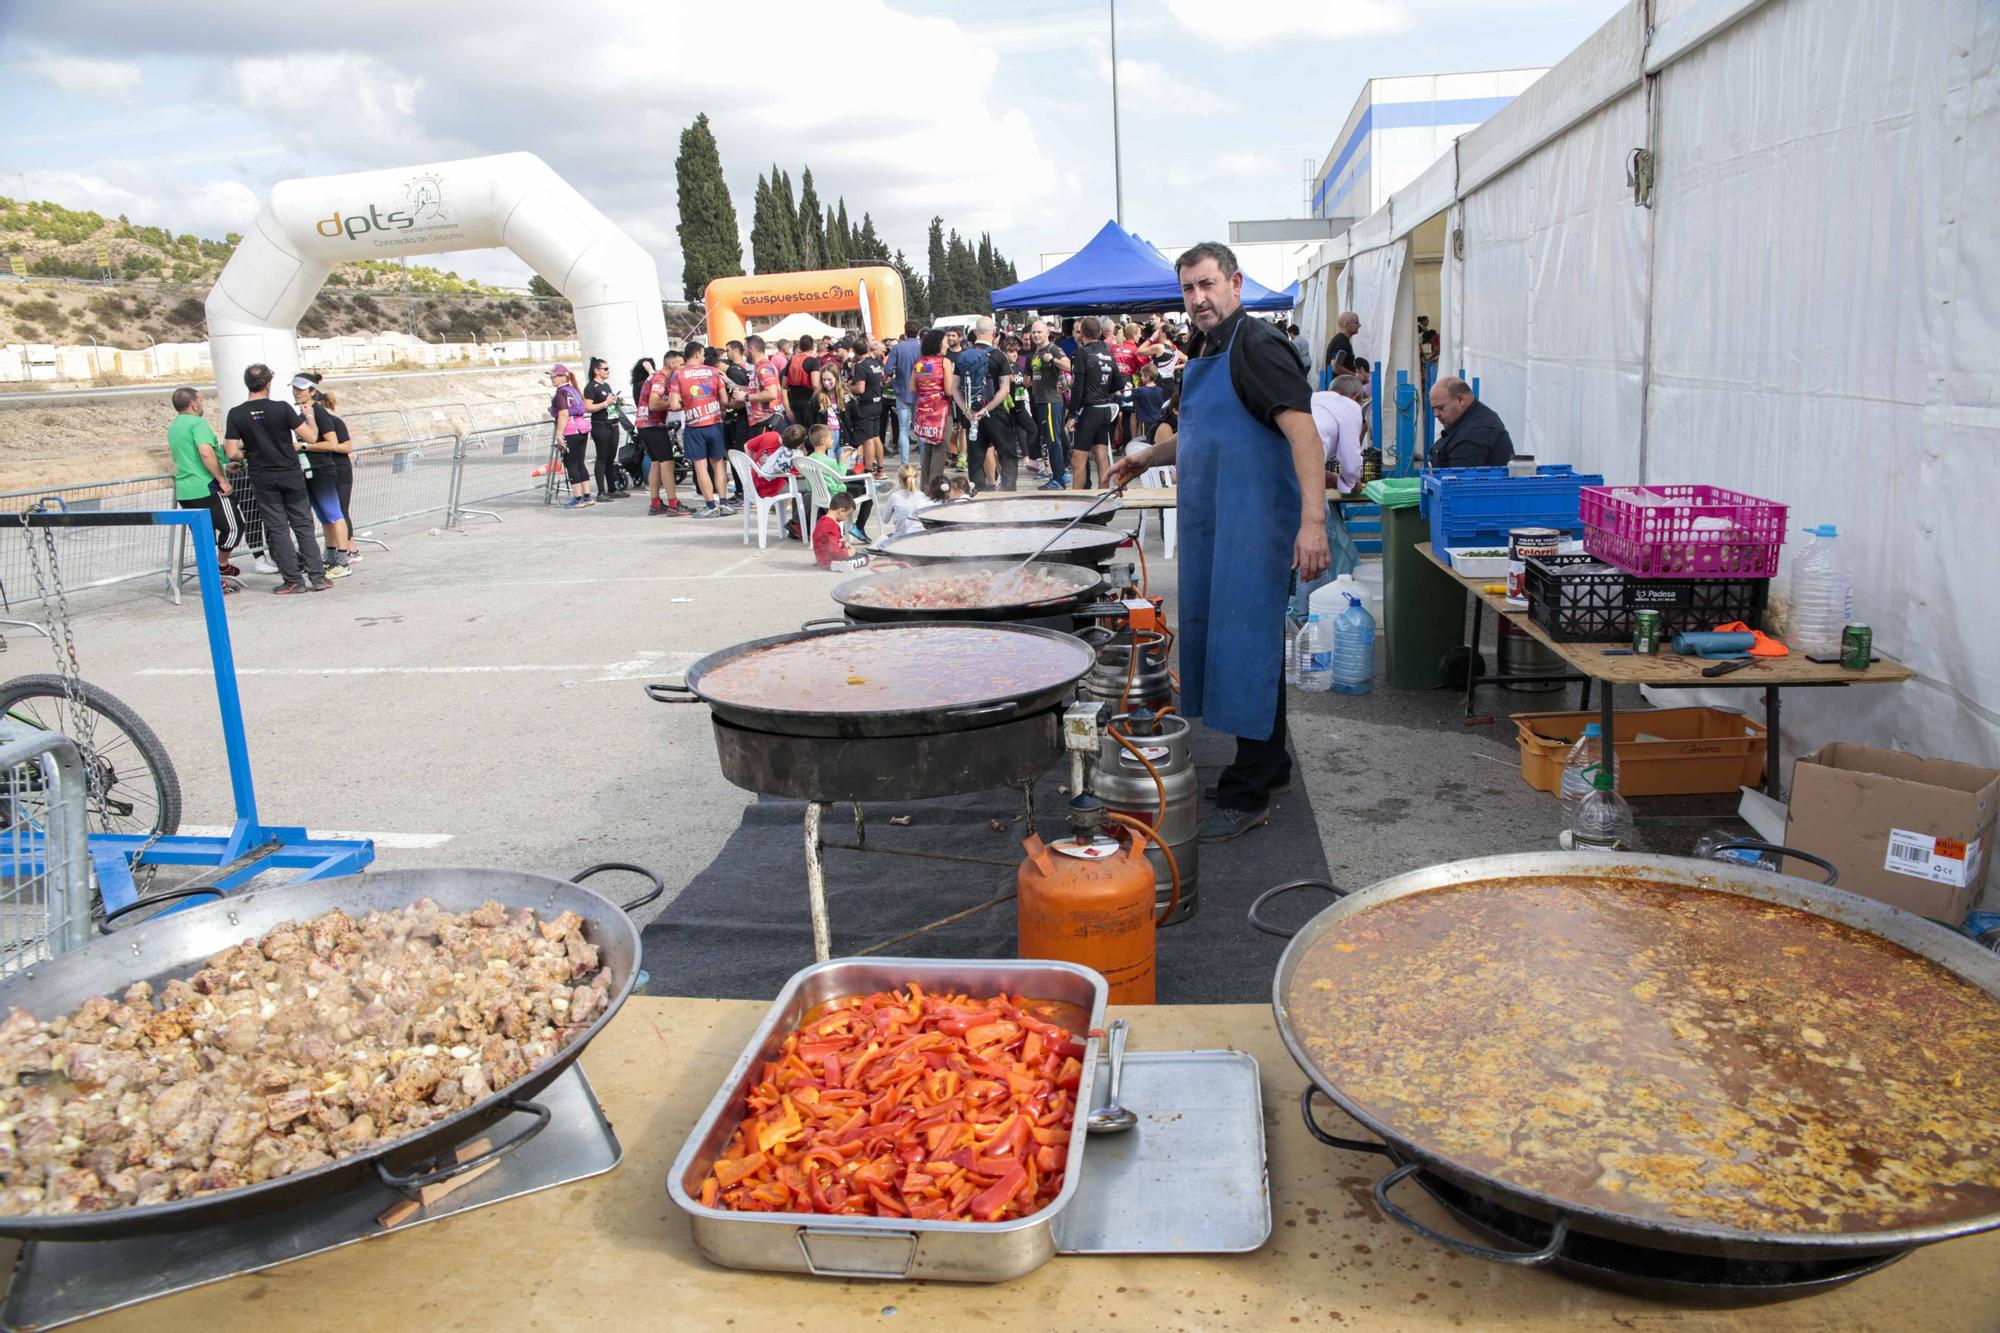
top-left (1418, 542), bottom-right (1916, 797)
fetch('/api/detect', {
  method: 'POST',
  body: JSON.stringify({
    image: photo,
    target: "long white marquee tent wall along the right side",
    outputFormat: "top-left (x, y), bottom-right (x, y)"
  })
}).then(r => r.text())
top-left (1304, 0), bottom-right (2000, 765)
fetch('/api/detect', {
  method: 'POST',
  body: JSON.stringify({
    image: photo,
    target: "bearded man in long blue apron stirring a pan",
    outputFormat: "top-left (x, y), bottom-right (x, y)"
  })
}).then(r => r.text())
top-left (1110, 242), bottom-right (1328, 843)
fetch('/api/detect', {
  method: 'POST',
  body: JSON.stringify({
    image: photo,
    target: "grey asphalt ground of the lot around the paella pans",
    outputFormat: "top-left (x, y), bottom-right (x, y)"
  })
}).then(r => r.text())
top-left (39, 496), bottom-right (1734, 944)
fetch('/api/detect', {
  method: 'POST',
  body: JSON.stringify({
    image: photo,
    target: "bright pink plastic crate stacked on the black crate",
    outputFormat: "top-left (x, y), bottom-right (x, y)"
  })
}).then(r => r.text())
top-left (1578, 486), bottom-right (1788, 578)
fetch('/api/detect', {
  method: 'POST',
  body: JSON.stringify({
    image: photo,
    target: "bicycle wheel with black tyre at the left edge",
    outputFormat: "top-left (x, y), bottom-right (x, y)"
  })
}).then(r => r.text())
top-left (0, 675), bottom-right (180, 837)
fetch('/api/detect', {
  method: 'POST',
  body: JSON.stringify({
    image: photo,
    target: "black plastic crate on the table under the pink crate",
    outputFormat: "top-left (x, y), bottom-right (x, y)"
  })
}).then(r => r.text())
top-left (1528, 554), bottom-right (1770, 646)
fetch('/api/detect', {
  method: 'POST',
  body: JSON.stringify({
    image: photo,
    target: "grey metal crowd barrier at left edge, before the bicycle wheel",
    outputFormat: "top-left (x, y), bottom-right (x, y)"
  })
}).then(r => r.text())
top-left (0, 721), bottom-right (90, 977)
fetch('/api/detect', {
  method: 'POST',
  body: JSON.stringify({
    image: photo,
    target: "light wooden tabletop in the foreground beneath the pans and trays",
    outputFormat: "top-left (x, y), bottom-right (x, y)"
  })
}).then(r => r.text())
top-left (23, 999), bottom-right (2000, 1333)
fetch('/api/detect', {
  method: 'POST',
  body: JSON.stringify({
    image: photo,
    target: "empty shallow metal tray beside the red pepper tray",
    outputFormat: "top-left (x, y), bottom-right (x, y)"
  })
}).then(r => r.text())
top-left (1056, 1051), bottom-right (1270, 1255)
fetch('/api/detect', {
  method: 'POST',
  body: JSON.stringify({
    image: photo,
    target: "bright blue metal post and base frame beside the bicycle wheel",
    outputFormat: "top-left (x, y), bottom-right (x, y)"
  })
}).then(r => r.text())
top-left (0, 508), bottom-right (374, 911)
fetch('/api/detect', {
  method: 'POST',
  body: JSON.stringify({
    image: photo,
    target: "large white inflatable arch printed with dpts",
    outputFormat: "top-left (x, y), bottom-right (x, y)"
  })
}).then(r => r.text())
top-left (208, 152), bottom-right (666, 410)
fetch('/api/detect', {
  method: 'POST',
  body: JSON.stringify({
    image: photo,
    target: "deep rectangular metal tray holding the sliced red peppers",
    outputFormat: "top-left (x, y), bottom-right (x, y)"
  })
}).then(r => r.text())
top-left (666, 959), bottom-right (1108, 1283)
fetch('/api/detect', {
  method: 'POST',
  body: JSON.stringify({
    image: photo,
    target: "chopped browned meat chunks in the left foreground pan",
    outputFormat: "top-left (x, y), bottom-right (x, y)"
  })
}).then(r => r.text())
top-left (0, 899), bottom-right (610, 1215)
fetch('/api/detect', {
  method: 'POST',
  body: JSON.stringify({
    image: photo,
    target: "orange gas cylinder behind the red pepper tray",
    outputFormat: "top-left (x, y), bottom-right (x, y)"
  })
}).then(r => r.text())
top-left (1016, 793), bottom-right (1158, 1005)
